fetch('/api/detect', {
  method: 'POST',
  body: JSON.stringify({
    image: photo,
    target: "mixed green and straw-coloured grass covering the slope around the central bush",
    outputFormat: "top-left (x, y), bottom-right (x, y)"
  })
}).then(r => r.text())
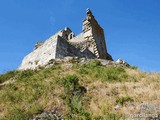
top-left (0, 59), bottom-right (160, 120)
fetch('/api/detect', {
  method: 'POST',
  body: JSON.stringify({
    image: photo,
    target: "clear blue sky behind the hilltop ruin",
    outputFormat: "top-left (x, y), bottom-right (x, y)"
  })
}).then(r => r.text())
top-left (0, 0), bottom-right (160, 73)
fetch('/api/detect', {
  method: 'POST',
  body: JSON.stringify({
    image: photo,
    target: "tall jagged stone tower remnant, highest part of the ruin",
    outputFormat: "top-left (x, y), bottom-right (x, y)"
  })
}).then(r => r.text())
top-left (82, 9), bottom-right (112, 60)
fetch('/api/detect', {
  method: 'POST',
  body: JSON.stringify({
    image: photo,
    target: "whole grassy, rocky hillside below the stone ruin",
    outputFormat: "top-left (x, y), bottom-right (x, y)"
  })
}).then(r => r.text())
top-left (0, 59), bottom-right (160, 120)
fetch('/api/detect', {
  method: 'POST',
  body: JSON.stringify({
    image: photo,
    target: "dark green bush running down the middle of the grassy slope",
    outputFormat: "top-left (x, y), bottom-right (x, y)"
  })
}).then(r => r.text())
top-left (61, 75), bottom-right (90, 119)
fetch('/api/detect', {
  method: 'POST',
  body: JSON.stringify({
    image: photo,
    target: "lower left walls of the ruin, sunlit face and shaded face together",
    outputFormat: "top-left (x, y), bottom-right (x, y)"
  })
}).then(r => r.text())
top-left (18, 28), bottom-right (95, 70)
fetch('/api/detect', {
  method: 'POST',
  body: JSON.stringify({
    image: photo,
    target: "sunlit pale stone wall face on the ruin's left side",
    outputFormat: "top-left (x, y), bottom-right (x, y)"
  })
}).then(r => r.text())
top-left (18, 35), bottom-right (57, 69)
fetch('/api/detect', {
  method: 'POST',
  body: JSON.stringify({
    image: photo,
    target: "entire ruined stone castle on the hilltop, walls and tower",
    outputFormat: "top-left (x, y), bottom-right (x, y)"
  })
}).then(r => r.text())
top-left (18, 9), bottom-right (113, 70)
